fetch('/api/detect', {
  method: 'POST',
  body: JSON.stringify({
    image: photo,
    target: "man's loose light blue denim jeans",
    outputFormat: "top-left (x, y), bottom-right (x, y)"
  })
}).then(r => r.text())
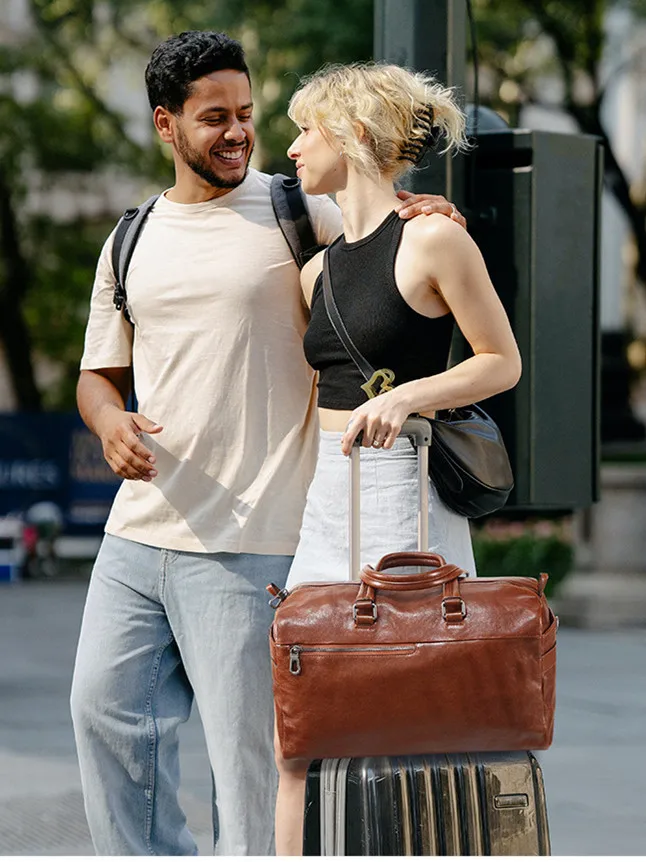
top-left (71, 535), bottom-right (291, 856)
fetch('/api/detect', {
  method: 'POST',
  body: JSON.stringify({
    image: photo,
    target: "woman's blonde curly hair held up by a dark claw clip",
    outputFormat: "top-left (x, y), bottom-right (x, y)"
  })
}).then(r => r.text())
top-left (288, 63), bottom-right (469, 179)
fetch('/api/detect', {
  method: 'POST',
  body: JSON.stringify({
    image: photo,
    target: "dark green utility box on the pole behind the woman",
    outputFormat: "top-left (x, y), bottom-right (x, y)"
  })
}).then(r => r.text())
top-left (466, 129), bottom-right (603, 510)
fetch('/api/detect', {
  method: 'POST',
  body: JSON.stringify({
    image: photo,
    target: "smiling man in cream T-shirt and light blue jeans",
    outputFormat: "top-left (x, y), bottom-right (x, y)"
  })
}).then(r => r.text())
top-left (72, 32), bottom-right (461, 855)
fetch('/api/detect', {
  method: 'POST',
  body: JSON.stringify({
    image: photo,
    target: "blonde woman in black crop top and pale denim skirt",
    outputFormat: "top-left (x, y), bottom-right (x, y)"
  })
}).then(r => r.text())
top-left (276, 64), bottom-right (521, 855)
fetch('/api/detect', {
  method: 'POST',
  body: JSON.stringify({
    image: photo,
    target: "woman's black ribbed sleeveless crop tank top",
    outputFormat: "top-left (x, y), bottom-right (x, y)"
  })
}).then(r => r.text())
top-left (304, 211), bottom-right (453, 410)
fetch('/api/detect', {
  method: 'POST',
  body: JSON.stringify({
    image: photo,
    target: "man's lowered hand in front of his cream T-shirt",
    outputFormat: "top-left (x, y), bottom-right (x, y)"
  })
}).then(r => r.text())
top-left (96, 405), bottom-right (163, 482)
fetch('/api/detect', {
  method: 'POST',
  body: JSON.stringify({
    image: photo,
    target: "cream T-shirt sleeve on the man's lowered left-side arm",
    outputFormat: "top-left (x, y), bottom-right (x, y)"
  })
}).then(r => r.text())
top-left (81, 226), bottom-right (133, 371)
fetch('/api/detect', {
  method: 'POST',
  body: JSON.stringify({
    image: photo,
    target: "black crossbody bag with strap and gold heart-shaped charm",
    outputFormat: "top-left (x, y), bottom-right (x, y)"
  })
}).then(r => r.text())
top-left (323, 251), bottom-right (514, 518)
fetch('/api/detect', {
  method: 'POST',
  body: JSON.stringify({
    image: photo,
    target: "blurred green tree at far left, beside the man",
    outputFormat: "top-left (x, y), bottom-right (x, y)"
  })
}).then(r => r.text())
top-left (0, 0), bottom-right (197, 410)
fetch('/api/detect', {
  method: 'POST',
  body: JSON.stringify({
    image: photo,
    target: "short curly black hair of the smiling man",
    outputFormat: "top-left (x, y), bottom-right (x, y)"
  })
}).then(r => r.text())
top-left (146, 30), bottom-right (251, 114)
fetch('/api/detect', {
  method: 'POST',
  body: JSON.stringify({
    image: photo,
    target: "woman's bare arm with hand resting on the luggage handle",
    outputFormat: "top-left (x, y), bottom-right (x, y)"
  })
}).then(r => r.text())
top-left (342, 216), bottom-right (521, 454)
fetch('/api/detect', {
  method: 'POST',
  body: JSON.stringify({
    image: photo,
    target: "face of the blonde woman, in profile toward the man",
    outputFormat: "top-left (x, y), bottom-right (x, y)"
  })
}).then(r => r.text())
top-left (287, 127), bottom-right (348, 195)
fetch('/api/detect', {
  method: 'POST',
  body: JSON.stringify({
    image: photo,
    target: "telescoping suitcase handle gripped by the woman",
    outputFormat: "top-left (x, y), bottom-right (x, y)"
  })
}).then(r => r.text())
top-left (349, 416), bottom-right (431, 581)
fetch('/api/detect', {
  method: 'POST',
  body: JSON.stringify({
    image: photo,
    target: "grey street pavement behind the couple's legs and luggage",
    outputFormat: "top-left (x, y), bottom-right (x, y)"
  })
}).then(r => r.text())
top-left (0, 578), bottom-right (646, 856)
